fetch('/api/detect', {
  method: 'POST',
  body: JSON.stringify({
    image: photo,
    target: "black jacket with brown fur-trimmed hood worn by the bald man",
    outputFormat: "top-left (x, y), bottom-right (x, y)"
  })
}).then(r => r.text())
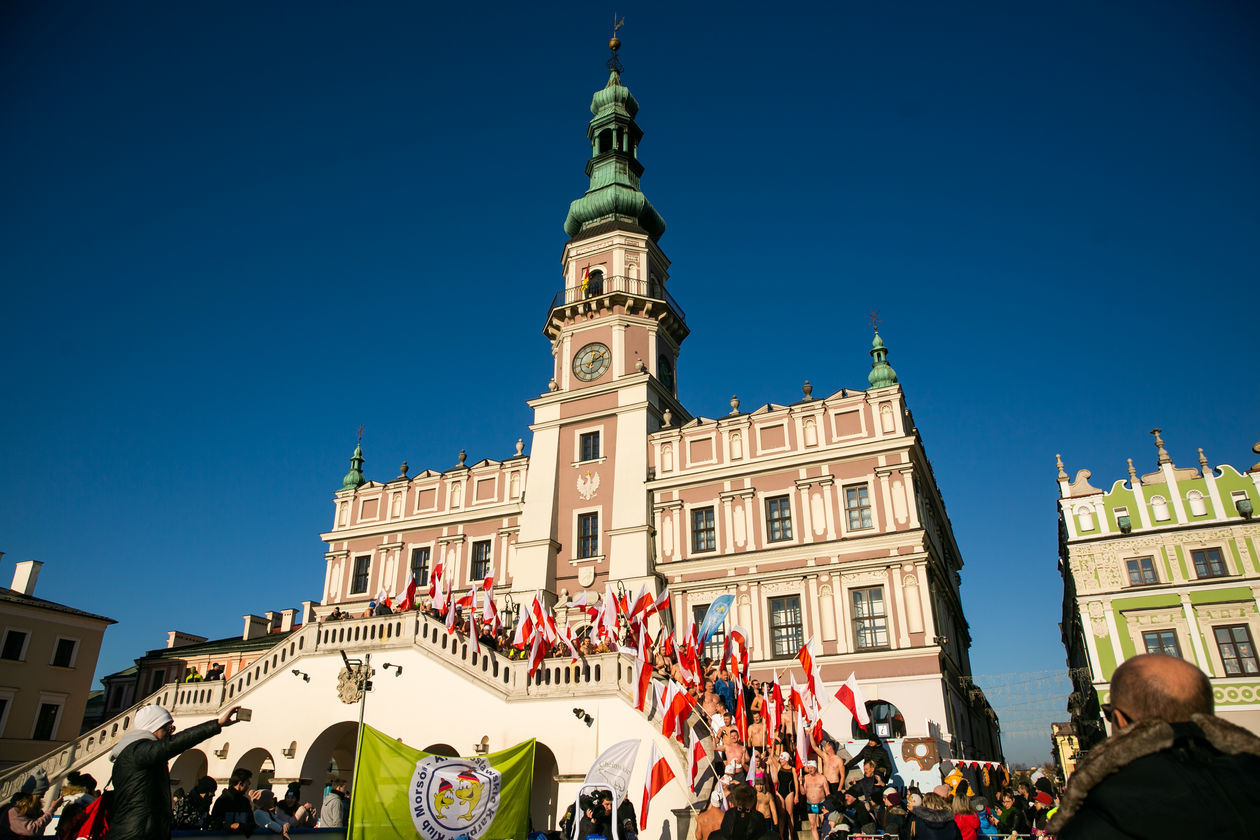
top-left (1046, 714), bottom-right (1260, 840)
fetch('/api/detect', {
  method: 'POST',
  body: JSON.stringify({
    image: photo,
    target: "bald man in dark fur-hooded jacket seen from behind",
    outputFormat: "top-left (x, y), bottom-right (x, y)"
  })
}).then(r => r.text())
top-left (1046, 654), bottom-right (1260, 840)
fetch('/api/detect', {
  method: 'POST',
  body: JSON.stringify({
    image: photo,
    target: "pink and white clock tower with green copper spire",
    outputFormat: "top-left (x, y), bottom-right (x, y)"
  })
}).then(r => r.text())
top-left (512, 38), bottom-right (690, 598)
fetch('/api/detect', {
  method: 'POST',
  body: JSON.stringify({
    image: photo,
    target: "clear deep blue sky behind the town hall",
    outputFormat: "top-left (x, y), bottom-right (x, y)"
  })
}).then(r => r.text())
top-left (0, 0), bottom-right (1260, 759)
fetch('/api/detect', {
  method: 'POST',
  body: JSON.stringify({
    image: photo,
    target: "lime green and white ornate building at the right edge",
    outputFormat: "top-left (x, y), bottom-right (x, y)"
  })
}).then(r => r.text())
top-left (1058, 429), bottom-right (1260, 749)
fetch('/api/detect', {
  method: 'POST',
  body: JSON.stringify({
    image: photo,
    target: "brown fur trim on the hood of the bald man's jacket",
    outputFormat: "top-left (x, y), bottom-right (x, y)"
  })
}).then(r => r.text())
top-left (1046, 714), bottom-right (1260, 834)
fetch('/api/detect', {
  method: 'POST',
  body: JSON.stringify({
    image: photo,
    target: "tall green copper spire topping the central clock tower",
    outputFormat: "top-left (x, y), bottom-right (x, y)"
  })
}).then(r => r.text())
top-left (564, 38), bottom-right (665, 241)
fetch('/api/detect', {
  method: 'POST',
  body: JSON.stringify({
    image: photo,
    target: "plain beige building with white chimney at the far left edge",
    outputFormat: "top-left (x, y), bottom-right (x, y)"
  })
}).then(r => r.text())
top-left (0, 560), bottom-right (115, 767)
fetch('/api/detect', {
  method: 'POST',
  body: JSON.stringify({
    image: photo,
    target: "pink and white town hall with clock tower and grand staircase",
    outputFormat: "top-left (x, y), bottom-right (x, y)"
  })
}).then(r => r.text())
top-left (5, 47), bottom-right (1002, 837)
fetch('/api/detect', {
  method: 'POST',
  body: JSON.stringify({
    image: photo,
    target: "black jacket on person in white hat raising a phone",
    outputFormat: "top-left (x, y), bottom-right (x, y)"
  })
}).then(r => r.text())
top-left (110, 720), bottom-right (223, 840)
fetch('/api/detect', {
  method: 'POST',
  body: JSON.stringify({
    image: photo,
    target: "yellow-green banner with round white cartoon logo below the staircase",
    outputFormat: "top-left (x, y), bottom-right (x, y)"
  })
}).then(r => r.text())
top-left (347, 725), bottom-right (534, 840)
